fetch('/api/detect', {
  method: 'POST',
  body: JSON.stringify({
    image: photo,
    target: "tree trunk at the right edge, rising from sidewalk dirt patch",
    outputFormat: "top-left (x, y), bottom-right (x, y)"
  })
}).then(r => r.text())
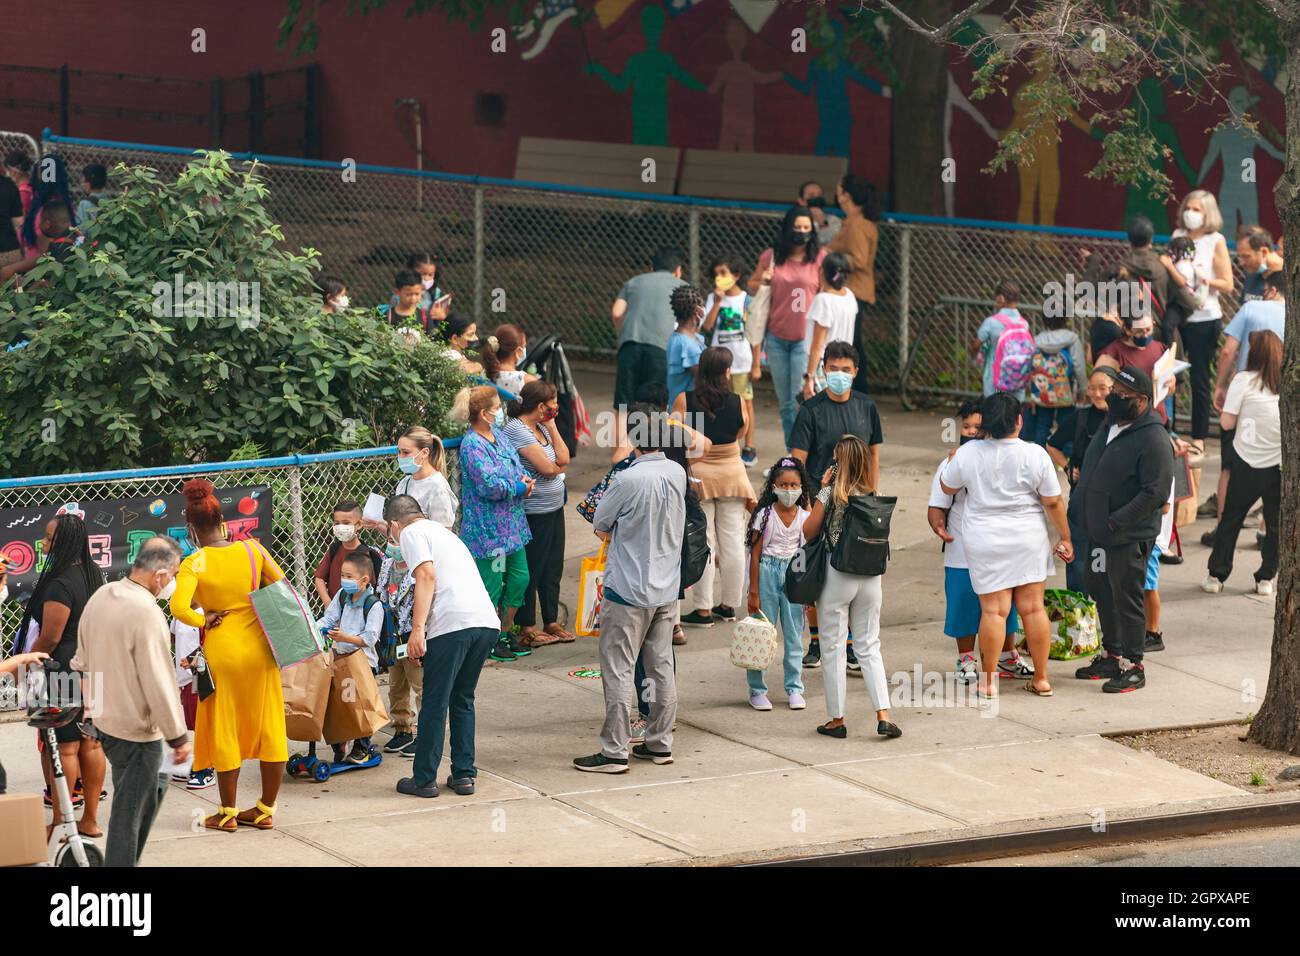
top-left (1249, 10), bottom-right (1300, 754)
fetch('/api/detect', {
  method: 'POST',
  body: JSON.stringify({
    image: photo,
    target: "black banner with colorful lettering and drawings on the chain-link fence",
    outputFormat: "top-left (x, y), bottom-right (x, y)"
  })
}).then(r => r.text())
top-left (0, 485), bottom-right (270, 601)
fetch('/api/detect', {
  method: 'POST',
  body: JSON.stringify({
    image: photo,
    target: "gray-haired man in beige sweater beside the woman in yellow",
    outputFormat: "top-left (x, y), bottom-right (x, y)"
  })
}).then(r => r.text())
top-left (72, 535), bottom-right (190, 866)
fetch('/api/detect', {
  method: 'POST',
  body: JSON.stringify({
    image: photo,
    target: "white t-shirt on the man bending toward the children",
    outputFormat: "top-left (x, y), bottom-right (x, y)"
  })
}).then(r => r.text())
top-left (400, 520), bottom-right (501, 639)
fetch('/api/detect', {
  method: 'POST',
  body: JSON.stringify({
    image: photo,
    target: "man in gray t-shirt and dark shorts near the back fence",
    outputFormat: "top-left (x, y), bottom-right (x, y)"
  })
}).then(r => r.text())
top-left (610, 248), bottom-right (685, 408)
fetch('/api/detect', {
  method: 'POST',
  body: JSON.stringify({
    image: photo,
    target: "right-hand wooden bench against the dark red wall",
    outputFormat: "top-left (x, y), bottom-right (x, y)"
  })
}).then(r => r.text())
top-left (677, 150), bottom-right (849, 206)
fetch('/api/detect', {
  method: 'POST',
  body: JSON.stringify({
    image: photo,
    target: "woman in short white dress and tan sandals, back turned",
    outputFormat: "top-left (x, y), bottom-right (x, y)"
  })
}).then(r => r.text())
top-left (940, 392), bottom-right (1074, 697)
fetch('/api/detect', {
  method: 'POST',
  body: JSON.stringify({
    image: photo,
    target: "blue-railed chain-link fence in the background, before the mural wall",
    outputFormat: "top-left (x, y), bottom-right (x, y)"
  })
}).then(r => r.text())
top-left (27, 135), bottom-right (1242, 411)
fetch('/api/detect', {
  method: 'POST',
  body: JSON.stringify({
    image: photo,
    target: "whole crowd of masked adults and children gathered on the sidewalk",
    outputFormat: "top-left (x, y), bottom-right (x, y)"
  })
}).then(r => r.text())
top-left (0, 164), bottom-right (1284, 865)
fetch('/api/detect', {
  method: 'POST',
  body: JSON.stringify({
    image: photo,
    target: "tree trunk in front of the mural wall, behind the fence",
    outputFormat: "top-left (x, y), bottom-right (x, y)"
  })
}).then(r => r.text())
top-left (888, 0), bottom-right (951, 216)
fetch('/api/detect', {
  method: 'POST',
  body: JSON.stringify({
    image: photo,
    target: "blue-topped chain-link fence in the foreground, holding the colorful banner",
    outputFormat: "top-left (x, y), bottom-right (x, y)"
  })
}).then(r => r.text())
top-left (0, 438), bottom-right (460, 708)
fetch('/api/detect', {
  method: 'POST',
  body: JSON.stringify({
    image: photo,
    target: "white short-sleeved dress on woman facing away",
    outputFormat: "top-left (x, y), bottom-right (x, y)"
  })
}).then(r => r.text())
top-left (943, 438), bottom-right (1061, 594)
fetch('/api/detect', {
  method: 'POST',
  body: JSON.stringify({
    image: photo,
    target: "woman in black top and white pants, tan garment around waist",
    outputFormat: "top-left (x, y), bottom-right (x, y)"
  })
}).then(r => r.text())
top-left (672, 346), bottom-right (754, 627)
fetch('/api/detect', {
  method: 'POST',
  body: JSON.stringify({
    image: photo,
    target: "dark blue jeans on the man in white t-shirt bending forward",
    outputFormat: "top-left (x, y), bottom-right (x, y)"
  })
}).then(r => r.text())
top-left (411, 627), bottom-right (501, 787)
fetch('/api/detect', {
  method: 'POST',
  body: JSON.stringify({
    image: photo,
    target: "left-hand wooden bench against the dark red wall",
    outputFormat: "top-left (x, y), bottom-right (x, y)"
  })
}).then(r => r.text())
top-left (515, 137), bottom-right (681, 196)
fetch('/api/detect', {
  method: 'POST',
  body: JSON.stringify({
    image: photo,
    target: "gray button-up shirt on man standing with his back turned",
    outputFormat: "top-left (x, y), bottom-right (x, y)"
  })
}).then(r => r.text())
top-left (592, 451), bottom-right (686, 607)
